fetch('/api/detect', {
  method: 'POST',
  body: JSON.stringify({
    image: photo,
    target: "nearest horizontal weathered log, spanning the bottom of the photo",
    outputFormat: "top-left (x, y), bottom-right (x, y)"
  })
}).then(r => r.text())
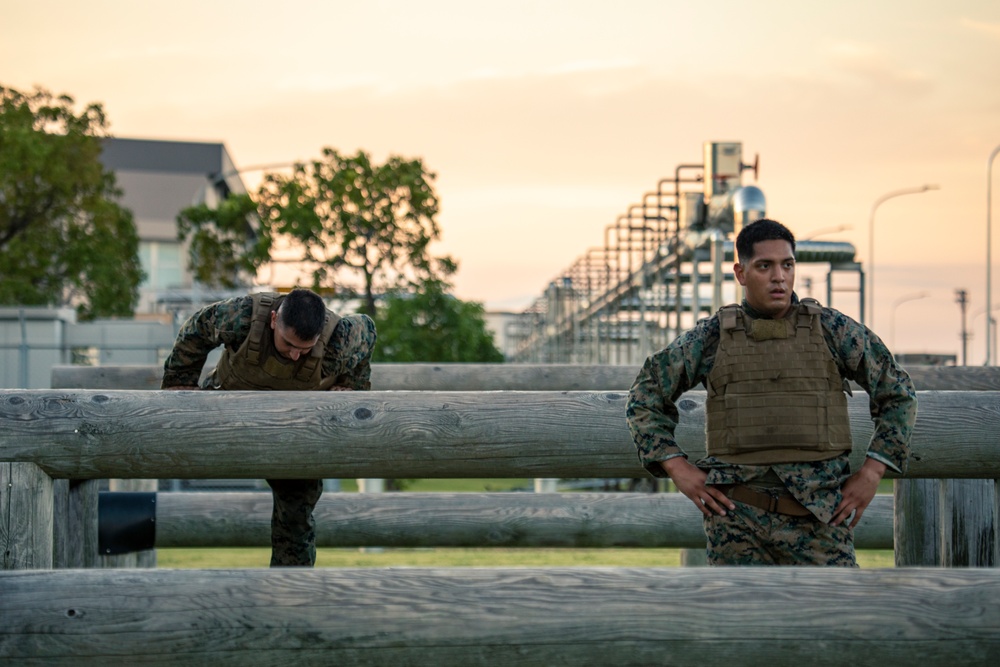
top-left (0, 568), bottom-right (1000, 667)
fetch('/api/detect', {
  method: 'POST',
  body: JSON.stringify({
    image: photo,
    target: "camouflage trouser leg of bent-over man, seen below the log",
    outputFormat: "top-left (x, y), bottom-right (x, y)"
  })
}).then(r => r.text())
top-left (267, 479), bottom-right (323, 567)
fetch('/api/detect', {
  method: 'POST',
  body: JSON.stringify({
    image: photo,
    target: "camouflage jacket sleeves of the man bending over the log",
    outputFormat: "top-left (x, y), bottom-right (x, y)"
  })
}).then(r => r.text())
top-left (160, 296), bottom-right (376, 390)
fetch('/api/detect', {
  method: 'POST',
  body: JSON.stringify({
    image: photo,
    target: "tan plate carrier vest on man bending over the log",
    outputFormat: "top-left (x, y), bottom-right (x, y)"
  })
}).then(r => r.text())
top-left (212, 292), bottom-right (340, 391)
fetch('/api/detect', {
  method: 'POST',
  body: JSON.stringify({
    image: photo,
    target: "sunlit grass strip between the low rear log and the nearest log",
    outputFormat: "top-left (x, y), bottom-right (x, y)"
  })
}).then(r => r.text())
top-left (157, 548), bottom-right (893, 569)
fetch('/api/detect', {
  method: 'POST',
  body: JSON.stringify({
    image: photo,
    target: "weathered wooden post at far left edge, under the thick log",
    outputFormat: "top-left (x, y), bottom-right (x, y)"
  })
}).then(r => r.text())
top-left (0, 462), bottom-right (53, 568)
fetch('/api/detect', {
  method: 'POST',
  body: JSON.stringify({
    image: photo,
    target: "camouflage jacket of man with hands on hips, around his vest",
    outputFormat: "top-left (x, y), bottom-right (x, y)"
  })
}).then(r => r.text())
top-left (626, 294), bottom-right (917, 522)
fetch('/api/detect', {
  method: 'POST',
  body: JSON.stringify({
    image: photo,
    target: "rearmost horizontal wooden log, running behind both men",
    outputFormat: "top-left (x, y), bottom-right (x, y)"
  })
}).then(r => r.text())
top-left (52, 363), bottom-right (1000, 391)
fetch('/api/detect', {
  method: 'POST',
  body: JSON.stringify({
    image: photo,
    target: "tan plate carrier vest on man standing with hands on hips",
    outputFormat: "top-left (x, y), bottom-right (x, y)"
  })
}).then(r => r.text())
top-left (705, 299), bottom-right (851, 465)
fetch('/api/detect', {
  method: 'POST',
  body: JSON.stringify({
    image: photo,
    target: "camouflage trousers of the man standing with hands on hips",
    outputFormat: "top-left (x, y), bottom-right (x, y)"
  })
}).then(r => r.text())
top-left (705, 502), bottom-right (858, 567)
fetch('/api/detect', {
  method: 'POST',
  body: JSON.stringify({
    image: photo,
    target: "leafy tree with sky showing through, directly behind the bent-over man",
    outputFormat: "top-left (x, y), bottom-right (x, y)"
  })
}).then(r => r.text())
top-left (178, 148), bottom-right (457, 315)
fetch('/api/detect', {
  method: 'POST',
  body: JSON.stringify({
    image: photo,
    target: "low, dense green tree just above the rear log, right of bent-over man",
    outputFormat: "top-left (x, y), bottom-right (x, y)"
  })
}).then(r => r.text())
top-left (373, 281), bottom-right (504, 362)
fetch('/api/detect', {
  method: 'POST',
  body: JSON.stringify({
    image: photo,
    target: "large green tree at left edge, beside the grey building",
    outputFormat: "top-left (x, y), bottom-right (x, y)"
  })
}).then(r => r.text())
top-left (0, 86), bottom-right (144, 319)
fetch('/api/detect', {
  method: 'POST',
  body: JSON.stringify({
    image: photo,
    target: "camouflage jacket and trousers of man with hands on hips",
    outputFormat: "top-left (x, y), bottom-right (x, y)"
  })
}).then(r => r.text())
top-left (626, 294), bottom-right (916, 566)
